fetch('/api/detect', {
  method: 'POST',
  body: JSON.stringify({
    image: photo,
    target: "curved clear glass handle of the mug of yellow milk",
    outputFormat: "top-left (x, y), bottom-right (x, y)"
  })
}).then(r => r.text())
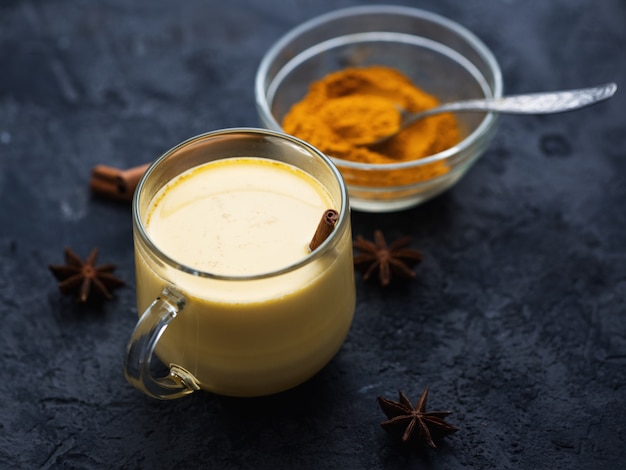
top-left (124, 286), bottom-right (200, 400)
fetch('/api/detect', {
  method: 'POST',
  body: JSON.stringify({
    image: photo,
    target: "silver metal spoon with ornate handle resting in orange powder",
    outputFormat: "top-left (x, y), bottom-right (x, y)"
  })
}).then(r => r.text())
top-left (361, 83), bottom-right (617, 145)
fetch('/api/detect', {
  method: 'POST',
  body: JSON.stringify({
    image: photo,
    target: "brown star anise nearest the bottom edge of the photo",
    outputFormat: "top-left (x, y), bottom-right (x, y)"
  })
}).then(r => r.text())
top-left (378, 388), bottom-right (459, 448)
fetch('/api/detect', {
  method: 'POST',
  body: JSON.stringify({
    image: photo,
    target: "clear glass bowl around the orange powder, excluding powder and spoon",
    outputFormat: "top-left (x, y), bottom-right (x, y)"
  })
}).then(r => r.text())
top-left (255, 5), bottom-right (502, 212)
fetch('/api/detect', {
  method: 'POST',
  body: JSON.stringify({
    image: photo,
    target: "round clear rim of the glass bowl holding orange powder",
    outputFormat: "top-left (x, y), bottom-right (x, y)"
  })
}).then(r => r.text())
top-left (254, 5), bottom-right (503, 171)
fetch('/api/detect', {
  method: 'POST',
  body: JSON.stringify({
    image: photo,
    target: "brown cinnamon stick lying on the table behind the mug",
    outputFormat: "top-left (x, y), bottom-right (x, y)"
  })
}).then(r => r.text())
top-left (89, 163), bottom-right (150, 202)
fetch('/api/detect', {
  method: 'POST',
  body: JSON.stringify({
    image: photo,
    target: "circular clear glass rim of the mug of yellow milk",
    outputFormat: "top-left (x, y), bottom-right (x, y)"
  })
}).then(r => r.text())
top-left (132, 127), bottom-right (350, 281)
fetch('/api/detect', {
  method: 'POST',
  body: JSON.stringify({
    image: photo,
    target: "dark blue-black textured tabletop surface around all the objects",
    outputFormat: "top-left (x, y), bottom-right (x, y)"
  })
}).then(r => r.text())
top-left (0, 0), bottom-right (626, 469)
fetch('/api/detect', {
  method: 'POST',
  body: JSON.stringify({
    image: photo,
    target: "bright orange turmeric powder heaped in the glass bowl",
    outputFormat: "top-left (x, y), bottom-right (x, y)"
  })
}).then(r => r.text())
top-left (282, 66), bottom-right (460, 186)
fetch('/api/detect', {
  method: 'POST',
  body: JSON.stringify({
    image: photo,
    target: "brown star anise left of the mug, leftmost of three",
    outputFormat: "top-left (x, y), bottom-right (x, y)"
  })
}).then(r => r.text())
top-left (48, 248), bottom-right (124, 302)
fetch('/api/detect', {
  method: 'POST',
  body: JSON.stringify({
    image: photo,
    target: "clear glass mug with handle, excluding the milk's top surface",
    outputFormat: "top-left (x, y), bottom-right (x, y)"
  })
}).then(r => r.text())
top-left (124, 128), bottom-right (356, 399)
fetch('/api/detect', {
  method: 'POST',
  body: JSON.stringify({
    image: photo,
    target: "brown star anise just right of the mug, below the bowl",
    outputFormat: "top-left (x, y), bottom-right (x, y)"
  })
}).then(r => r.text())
top-left (354, 230), bottom-right (422, 286)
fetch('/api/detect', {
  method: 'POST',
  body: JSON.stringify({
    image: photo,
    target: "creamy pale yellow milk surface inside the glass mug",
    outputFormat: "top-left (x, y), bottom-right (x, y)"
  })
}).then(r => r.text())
top-left (146, 157), bottom-right (332, 276)
